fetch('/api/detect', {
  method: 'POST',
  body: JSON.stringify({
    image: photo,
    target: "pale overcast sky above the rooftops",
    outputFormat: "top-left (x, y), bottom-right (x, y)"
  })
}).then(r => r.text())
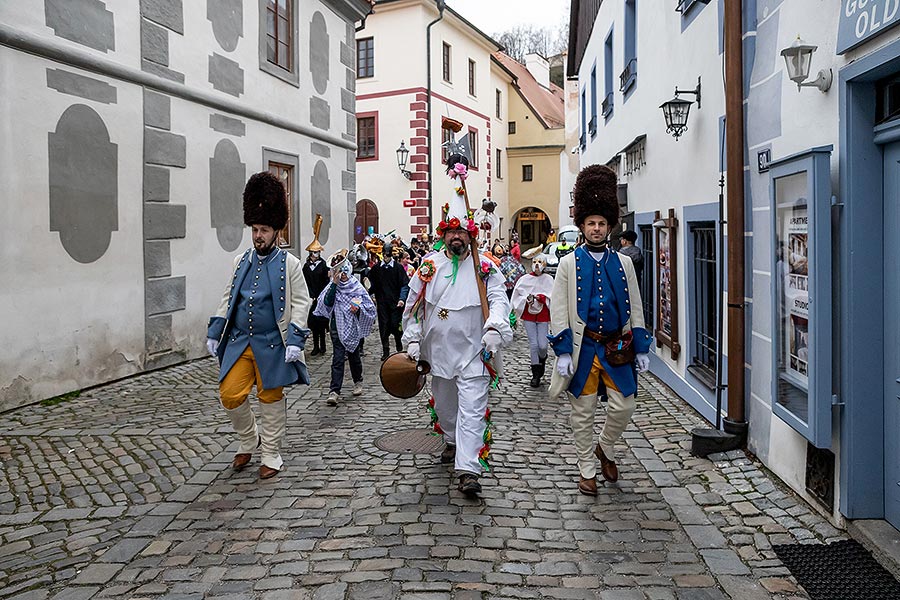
top-left (447, 0), bottom-right (570, 35)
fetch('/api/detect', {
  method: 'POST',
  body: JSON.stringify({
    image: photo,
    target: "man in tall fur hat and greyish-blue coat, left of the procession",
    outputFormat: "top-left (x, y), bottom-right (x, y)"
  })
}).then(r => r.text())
top-left (206, 171), bottom-right (310, 479)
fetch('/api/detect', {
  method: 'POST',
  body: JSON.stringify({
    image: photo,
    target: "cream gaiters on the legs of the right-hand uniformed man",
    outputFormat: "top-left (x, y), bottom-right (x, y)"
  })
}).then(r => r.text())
top-left (569, 387), bottom-right (634, 479)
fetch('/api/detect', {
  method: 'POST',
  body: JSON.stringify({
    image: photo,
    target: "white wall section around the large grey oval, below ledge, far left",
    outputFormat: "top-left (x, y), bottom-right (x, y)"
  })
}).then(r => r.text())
top-left (0, 47), bottom-right (144, 410)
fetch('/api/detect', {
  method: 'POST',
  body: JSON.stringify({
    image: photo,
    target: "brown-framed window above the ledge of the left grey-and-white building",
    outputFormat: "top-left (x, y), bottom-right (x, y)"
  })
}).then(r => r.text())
top-left (259, 0), bottom-right (300, 87)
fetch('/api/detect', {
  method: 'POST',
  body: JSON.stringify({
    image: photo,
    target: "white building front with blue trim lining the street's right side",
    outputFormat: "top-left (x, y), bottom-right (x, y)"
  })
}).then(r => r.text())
top-left (569, 0), bottom-right (900, 528)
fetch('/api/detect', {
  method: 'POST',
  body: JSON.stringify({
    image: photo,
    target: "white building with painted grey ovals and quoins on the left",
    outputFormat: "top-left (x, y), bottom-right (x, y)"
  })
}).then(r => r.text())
top-left (0, 0), bottom-right (370, 410)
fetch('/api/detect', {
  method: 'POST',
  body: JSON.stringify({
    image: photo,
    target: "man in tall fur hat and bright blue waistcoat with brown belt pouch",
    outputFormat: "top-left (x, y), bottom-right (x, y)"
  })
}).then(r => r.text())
top-left (550, 165), bottom-right (652, 496)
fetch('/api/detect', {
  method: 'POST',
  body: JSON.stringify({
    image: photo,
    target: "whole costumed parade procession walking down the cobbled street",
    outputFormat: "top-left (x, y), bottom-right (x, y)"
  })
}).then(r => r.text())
top-left (207, 153), bottom-right (651, 497)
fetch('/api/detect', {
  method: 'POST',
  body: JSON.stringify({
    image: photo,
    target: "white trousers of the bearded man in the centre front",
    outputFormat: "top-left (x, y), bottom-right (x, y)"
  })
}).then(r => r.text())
top-left (431, 376), bottom-right (490, 475)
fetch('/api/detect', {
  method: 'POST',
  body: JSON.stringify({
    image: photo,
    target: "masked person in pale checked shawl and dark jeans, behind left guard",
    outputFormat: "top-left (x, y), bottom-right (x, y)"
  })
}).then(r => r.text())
top-left (316, 249), bottom-right (375, 406)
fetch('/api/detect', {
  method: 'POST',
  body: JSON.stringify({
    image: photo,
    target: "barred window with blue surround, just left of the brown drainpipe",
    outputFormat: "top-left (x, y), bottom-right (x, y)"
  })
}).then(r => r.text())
top-left (688, 222), bottom-right (718, 387)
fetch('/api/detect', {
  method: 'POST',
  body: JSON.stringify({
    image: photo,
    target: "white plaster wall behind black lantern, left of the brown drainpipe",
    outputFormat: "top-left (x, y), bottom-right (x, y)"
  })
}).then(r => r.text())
top-left (570, 2), bottom-right (725, 384)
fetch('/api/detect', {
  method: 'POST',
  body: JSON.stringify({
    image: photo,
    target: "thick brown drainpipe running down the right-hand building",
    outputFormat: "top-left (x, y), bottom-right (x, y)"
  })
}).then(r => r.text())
top-left (725, 0), bottom-right (747, 443)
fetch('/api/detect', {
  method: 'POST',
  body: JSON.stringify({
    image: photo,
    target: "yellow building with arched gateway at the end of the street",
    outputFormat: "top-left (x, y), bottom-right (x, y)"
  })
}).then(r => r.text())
top-left (494, 52), bottom-right (566, 250)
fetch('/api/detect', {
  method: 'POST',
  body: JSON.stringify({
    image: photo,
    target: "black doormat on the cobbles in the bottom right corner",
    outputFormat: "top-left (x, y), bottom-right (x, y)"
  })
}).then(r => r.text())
top-left (772, 540), bottom-right (900, 600)
